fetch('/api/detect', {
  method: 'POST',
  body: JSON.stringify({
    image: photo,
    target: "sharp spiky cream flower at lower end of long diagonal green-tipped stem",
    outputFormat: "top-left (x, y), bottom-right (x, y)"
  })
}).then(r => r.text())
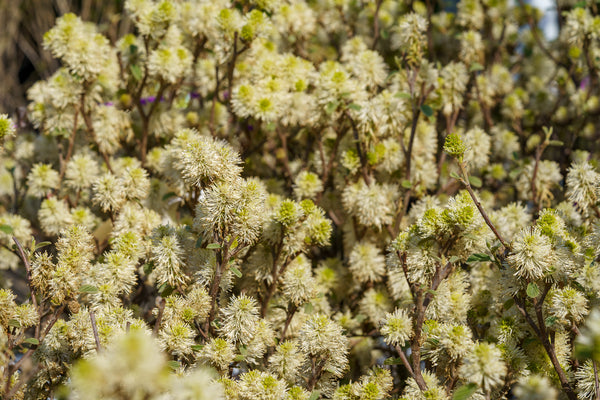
top-left (508, 227), bottom-right (556, 280)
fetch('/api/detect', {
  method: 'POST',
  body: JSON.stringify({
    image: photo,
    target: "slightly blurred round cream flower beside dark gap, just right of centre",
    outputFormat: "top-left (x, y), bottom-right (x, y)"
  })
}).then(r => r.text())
top-left (348, 241), bottom-right (385, 283)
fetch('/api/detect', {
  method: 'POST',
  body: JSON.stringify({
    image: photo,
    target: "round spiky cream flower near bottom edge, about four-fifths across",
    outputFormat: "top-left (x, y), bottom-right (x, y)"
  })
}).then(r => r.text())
top-left (460, 342), bottom-right (506, 392)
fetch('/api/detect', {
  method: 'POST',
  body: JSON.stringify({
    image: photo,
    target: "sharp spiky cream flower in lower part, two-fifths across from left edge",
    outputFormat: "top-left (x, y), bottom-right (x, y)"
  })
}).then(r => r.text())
top-left (221, 294), bottom-right (259, 344)
